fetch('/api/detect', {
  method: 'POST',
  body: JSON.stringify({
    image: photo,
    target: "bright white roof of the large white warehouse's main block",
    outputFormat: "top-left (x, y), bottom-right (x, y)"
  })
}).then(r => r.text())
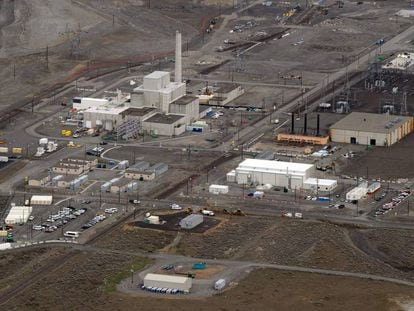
top-left (237, 159), bottom-right (313, 175)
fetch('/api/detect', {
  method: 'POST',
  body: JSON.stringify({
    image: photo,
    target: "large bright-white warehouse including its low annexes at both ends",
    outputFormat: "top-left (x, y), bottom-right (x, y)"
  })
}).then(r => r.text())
top-left (231, 159), bottom-right (337, 191)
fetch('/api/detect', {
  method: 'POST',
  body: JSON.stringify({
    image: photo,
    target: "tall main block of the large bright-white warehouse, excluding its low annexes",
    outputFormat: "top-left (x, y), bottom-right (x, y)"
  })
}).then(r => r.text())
top-left (236, 159), bottom-right (315, 189)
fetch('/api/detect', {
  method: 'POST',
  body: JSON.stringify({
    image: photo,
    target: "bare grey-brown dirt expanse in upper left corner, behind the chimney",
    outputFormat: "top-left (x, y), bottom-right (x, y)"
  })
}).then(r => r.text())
top-left (0, 0), bottom-right (216, 114)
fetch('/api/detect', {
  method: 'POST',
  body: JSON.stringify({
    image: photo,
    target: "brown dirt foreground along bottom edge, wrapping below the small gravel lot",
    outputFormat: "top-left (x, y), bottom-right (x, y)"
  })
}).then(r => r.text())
top-left (8, 253), bottom-right (414, 311)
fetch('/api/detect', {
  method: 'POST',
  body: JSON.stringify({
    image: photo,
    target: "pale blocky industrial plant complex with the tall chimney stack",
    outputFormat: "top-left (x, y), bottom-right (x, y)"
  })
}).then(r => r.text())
top-left (73, 31), bottom-right (205, 137)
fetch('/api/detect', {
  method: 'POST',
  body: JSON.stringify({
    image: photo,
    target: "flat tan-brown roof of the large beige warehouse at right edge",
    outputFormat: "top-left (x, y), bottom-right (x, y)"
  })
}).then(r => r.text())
top-left (330, 112), bottom-right (412, 133)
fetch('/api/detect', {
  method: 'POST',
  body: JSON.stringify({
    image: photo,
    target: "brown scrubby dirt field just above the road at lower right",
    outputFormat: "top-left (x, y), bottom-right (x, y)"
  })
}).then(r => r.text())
top-left (177, 217), bottom-right (414, 279)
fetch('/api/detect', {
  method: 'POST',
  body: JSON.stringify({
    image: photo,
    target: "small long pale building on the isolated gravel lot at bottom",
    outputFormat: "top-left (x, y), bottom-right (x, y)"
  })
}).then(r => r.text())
top-left (144, 273), bottom-right (193, 293)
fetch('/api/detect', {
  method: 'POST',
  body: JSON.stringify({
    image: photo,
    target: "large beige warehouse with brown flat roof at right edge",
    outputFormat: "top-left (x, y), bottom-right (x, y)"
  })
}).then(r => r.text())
top-left (330, 112), bottom-right (414, 146)
